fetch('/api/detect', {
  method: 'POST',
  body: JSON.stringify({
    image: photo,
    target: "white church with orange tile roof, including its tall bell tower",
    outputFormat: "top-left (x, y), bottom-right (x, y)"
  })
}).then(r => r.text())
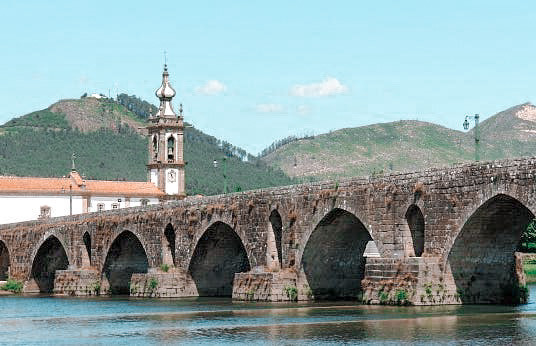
top-left (0, 66), bottom-right (186, 224)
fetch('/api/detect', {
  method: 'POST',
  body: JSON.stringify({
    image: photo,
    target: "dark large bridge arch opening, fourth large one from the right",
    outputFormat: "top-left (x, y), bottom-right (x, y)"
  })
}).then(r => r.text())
top-left (102, 231), bottom-right (149, 294)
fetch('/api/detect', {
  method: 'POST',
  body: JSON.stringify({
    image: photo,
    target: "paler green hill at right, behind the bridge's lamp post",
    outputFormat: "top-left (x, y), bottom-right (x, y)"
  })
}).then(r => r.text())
top-left (262, 103), bottom-right (536, 179)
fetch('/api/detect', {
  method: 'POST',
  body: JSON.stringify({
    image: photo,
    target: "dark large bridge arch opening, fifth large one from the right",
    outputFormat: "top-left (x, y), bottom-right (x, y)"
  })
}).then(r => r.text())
top-left (31, 235), bottom-right (70, 293)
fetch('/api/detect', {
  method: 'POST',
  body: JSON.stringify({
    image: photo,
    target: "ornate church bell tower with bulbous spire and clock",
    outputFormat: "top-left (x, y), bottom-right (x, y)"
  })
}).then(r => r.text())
top-left (147, 64), bottom-right (186, 199)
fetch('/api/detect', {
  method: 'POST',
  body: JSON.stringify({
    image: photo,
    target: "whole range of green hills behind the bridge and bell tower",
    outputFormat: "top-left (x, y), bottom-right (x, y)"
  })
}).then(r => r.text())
top-left (4, 95), bottom-right (536, 194)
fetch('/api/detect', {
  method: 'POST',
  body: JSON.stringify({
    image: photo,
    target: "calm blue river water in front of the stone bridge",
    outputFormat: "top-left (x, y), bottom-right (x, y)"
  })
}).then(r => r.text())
top-left (0, 286), bottom-right (536, 345)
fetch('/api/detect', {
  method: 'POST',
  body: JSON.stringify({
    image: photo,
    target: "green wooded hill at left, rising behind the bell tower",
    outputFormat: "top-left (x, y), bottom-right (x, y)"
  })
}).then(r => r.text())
top-left (0, 98), bottom-right (292, 195)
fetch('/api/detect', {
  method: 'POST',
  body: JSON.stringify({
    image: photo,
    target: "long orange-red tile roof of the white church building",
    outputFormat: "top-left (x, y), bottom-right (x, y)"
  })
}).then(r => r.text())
top-left (0, 171), bottom-right (164, 197)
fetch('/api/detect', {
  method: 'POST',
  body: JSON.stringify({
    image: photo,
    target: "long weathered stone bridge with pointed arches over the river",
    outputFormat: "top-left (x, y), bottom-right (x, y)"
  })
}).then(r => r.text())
top-left (0, 158), bottom-right (536, 304)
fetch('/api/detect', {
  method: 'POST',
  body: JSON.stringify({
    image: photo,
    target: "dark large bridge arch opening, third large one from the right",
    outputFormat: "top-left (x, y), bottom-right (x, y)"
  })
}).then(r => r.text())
top-left (188, 221), bottom-right (251, 296)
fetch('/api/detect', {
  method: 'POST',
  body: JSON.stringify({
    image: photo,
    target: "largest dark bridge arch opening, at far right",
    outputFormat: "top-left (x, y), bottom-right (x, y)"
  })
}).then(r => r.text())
top-left (446, 194), bottom-right (534, 304)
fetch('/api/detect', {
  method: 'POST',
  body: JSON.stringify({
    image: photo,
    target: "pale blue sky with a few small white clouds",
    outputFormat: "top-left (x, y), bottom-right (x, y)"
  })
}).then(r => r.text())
top-left (0, 0), bottom-right (536, 154)
